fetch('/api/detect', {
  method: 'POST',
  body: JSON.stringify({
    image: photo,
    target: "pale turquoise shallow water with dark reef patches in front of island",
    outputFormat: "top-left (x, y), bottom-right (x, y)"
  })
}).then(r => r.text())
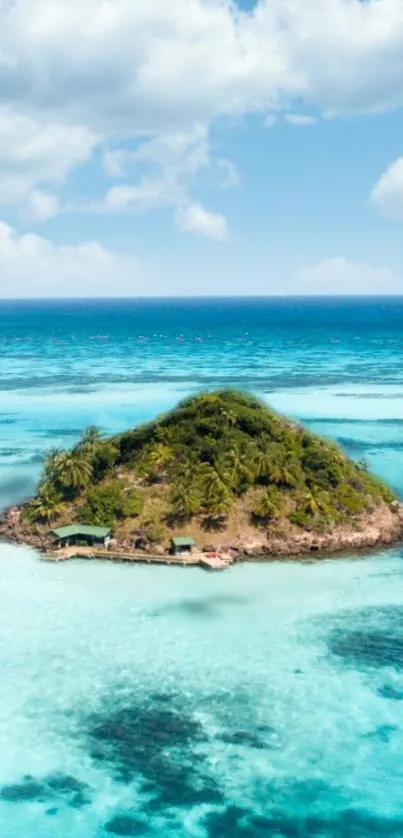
top-left (0, 548), bottom-right (403, 838)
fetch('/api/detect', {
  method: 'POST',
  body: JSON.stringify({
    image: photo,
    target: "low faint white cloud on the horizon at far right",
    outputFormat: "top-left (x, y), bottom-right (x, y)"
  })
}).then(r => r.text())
top-left (294, 257), bottom-right (403, 296)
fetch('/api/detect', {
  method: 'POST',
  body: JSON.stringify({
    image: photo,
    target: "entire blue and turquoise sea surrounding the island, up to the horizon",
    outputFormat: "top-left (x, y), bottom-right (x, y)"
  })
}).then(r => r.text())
top-left (0, 298), bottom-right (403, 838)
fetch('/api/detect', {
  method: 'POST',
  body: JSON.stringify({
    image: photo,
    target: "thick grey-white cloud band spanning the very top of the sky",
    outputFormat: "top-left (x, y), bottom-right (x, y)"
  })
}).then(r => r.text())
top-left (0, 0), bottom-right (403, 128)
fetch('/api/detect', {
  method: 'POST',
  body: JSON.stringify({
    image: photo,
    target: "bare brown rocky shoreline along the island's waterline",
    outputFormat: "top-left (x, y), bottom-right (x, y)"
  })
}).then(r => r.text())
top-left (0, 503), bottom-right (403, 561)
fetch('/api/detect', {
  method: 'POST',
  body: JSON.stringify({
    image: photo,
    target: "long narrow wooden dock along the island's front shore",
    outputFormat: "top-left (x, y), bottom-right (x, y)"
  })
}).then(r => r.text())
top-left (42, 547), bottom-right (231, 571)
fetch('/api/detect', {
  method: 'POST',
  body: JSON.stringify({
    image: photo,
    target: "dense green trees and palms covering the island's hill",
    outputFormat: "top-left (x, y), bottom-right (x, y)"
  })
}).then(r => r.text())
top-left (25, 391), bottom-right (396, 540)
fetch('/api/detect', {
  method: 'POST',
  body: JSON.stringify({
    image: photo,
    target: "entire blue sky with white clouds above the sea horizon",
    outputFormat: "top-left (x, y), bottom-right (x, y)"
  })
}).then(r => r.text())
top-left (0, 0), bottom-right (403, 297)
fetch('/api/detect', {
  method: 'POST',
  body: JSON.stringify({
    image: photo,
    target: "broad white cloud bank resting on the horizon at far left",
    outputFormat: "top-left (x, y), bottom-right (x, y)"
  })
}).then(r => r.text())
top-left (0, 222), bottom-right (148, 298)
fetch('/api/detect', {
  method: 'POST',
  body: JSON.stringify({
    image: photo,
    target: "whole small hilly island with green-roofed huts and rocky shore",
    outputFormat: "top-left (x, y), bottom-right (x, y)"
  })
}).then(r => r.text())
top-left (0, 391), bottom-right (403, 567)
